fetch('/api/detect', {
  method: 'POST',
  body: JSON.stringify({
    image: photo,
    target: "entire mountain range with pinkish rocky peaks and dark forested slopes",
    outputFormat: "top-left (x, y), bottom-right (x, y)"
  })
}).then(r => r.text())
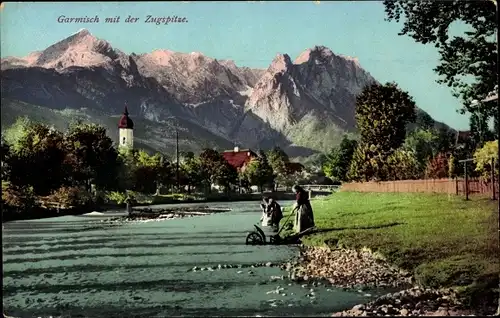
top-left (1, 29), bottom-right (452, 157)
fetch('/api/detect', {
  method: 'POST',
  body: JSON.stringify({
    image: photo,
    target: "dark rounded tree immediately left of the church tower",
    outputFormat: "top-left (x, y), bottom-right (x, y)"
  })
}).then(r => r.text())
top-left (64, 123), bottom-right (118, 190)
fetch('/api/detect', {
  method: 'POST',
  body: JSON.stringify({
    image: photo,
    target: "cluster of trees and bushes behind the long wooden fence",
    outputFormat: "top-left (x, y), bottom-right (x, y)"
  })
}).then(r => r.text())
top-left (323, 83), bottom-right (498, 181)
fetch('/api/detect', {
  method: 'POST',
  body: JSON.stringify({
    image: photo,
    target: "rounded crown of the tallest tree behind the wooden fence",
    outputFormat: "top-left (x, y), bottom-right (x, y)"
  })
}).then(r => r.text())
top-left (356, 83), bottom-right (416, 155)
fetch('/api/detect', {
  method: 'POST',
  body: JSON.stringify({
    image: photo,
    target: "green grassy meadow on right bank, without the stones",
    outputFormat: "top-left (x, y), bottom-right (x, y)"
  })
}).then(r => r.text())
top-left (282, 192), bottom-right (499, 310)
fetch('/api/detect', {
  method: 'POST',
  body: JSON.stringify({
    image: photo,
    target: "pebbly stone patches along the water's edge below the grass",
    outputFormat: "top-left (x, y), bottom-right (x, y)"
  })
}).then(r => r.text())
top-left (282, 246), bottom-right (492, 316)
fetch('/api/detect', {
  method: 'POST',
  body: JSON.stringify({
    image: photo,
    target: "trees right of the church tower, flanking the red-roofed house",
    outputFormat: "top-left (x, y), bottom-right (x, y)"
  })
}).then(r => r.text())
top-left (119, 147), bottom-right (302, 194)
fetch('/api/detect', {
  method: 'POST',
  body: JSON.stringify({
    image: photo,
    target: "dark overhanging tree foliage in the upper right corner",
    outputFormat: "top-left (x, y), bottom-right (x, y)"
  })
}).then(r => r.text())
top-left (384, 0), bottom-right (498, 117)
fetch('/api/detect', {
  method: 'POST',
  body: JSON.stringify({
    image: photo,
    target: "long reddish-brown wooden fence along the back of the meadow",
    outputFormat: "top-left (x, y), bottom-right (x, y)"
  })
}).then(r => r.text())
top-left (340, 179), bottom-right (499, 199)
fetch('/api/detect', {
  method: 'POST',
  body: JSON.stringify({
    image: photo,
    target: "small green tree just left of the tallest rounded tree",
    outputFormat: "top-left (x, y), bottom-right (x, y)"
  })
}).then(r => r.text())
top-left (323, 135), bottom-right (358, 181)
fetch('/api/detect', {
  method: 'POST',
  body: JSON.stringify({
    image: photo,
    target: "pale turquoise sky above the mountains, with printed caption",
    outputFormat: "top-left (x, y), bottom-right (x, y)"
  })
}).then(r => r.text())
top-left (0, 1), bottom-right (468, 130)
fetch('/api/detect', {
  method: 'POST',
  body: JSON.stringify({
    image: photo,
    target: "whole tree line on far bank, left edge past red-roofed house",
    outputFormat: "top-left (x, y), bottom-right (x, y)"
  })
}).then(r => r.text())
top-left (1, 118), bottom-right (310, 210)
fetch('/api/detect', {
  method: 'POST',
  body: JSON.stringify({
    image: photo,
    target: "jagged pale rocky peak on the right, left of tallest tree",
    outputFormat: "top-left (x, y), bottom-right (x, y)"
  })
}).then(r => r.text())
top-left (246, 45), bottom-right (374, 136)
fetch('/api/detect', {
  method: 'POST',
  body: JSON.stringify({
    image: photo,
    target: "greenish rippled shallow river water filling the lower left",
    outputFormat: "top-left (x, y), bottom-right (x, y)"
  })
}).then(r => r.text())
top-left (2, 202), bottom-right (386, 317)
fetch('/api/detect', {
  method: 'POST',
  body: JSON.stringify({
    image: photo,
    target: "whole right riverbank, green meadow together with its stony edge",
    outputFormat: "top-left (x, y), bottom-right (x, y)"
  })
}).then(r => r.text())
top-left (282, 192), bottom-right (499, 316)
